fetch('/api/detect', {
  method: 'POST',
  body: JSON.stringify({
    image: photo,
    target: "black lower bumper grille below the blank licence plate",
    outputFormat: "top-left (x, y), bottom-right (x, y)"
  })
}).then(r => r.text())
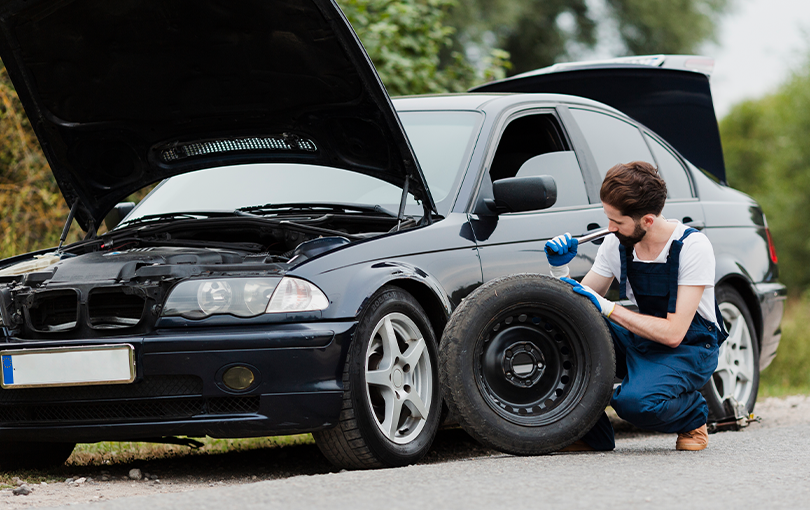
top-left (0, 376), bottom-right (259, 425)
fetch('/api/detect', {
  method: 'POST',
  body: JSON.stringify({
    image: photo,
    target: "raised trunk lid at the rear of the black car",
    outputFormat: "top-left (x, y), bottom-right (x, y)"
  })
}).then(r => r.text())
top-left (470, 55), bottom-right (726, 183)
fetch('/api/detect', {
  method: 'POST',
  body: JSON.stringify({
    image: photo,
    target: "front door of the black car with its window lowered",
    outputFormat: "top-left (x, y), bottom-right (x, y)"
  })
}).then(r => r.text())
top-left (470, 107), bottom-right (607, 281)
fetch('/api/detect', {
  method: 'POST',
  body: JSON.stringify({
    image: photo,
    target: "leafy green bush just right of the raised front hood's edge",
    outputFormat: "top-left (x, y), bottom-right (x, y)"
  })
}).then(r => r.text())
top-left (340, 0), bottom-right (509, 95)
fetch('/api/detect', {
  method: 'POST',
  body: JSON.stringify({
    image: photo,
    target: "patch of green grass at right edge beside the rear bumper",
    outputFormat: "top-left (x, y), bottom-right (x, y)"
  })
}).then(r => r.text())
top-left (759, 292), bottom-right (810, 398)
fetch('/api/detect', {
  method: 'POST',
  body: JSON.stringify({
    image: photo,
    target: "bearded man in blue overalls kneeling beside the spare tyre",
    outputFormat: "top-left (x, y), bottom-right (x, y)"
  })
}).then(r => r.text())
top-left (546, 161), bottom-right (727, 451)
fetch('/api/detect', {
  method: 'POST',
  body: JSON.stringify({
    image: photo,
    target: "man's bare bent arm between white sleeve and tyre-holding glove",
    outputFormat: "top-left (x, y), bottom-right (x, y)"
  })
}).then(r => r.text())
top-left (608, 284), bottom-right (705, 349)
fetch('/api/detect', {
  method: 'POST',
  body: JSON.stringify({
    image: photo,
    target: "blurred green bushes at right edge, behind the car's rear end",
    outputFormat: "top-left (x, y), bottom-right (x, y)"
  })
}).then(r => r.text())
top-left (720, 58), bottom-right (810, 294)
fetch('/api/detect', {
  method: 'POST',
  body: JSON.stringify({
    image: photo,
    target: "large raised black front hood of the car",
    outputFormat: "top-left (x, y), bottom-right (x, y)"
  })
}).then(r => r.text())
top-left (0, 0), bottom-right (435, 230)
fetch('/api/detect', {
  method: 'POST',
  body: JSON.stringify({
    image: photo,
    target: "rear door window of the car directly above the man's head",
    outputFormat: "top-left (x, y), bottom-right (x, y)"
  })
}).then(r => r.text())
top-left (570, 108), bottom-right (654, 181)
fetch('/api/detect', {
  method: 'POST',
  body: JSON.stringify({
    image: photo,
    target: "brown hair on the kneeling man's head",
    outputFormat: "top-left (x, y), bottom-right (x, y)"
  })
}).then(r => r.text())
top-left (599, 161), bottom-right (667, 220)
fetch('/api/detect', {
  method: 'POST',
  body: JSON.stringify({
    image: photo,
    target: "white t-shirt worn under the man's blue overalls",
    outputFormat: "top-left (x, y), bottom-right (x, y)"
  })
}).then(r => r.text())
top-left (593, 220), bottom-right (717, 323)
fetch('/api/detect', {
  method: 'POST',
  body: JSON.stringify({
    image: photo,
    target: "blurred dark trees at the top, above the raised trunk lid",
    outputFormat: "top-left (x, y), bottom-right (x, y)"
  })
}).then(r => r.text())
top-left (450, 0), bottom-right (731, 73)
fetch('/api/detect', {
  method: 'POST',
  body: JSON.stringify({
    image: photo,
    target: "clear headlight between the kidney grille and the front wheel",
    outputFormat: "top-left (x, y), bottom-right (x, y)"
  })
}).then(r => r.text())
top-left (163, 277), bottom-right (329, 319)
